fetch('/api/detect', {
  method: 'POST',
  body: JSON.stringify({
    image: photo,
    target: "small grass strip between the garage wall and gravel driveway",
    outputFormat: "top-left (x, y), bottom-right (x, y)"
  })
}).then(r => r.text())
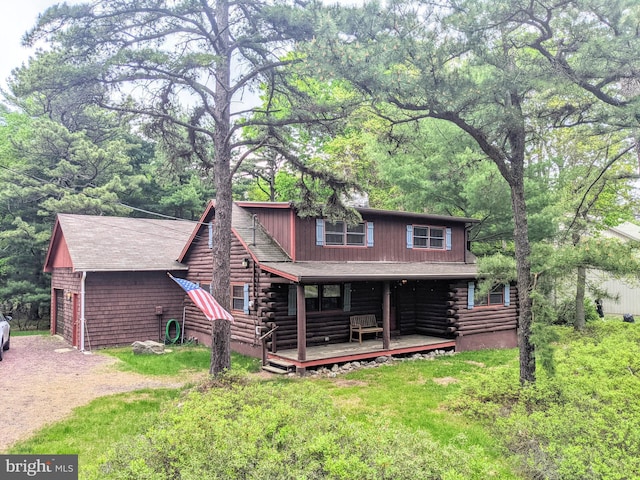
top-left (98, 346), bottom-right (260, 376)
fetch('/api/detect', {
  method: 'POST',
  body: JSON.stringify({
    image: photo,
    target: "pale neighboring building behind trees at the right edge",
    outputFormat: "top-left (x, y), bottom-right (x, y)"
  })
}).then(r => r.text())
top-left (588, 222), bottom-right (640, 316)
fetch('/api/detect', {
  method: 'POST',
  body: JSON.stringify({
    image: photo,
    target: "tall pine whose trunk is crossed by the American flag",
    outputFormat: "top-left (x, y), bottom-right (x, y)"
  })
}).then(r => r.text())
top-left (13, 0), bottom-right (358, 374)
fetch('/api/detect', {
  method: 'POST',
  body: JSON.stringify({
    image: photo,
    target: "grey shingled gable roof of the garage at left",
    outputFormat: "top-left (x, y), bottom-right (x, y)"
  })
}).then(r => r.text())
top-left (45, 214), bottom-right (196, 272)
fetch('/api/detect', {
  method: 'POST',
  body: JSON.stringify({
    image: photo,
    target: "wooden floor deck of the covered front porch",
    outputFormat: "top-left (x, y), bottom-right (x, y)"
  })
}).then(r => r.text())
top-left (267, 335), bottom-right (456, 369)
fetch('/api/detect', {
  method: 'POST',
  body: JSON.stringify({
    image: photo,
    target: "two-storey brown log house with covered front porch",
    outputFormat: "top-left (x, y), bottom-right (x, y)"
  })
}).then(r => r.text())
top-left (178, 202), bottom-right (517, 370)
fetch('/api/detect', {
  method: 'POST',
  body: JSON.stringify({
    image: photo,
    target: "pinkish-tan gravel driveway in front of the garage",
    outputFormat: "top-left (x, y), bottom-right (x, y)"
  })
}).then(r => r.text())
top-left (0, 335), bottom-right (204, 452)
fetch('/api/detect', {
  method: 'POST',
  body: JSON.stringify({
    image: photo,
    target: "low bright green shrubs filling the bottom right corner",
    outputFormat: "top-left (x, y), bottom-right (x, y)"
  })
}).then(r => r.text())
top-left (458, 322), bottom-right (640, 480)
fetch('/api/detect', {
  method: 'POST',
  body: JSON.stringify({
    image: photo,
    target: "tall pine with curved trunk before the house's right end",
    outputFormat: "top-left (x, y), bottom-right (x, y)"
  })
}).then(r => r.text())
top-left (306, 0), bottom-right (640, 384)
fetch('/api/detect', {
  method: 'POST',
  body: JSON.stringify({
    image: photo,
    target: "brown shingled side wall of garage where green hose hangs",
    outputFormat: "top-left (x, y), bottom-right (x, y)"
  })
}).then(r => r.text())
top-left (85, 272), bottom-right (184, 349)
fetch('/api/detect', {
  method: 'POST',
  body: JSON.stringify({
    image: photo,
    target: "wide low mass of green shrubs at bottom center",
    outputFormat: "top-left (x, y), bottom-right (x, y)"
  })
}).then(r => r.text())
top-left (100, 376), bottom-right (500, 480)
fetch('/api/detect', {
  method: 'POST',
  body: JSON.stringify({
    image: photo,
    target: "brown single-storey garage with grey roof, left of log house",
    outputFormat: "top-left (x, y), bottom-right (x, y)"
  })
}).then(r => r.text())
top-left (44, 214), bottom-right (195, 350)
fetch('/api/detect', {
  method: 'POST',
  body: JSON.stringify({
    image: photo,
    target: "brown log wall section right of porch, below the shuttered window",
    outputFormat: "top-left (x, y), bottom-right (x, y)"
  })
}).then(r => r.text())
top-left (453, 282), bottom-right (518, 336)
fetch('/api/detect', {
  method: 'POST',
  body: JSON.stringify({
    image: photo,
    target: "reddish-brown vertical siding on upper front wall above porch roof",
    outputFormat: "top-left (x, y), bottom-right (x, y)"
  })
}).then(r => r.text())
top-left (296, 216), bottom-right (466, 262)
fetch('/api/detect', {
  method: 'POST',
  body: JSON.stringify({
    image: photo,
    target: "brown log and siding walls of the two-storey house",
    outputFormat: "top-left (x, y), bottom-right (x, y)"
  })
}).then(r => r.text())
top-left (182, 202), bottom-right (517, 356)
